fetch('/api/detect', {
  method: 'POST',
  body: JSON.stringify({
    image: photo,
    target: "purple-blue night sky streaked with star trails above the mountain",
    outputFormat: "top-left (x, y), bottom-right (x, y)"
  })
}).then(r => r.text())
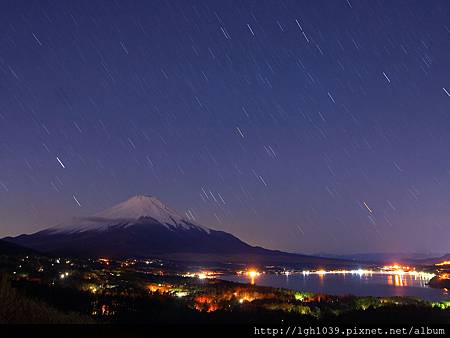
top-left (0, 0), bottom-right (450, 253)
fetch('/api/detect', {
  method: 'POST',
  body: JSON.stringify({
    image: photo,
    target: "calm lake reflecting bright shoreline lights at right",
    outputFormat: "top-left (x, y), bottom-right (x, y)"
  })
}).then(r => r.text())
top-left (220, 272), bottom-right (450, 301)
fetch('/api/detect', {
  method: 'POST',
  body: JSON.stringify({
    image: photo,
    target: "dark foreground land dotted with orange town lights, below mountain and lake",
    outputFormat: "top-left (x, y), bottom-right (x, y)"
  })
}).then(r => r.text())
top-left (0, 254), bottom-right (450, 325)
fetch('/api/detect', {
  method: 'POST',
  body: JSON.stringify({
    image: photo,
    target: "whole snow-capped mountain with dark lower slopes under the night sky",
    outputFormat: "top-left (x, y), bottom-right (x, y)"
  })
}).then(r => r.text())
top-left (1, 196), bottom-right (350, 266)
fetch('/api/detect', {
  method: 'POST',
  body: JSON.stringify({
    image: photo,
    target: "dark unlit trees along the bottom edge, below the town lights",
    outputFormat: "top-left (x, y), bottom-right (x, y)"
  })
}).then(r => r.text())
top-left (0, 274), bottom-right (450, 325)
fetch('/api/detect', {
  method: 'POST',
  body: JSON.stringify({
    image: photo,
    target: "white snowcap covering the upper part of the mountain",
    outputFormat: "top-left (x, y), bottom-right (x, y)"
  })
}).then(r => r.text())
top-left (50, 195), bottom-right (210, 233)
